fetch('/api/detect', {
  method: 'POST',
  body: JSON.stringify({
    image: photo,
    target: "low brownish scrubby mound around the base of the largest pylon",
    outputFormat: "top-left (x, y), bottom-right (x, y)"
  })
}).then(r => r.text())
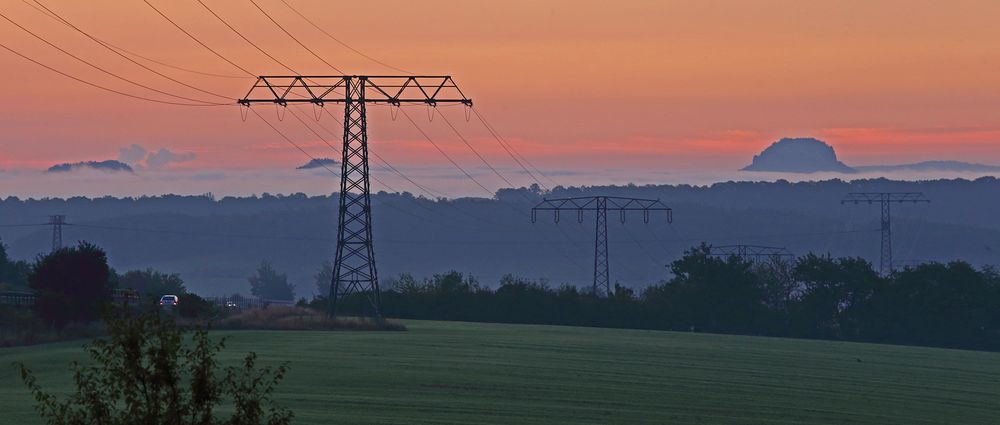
top-left (215, 307), bottom-right (406, 331)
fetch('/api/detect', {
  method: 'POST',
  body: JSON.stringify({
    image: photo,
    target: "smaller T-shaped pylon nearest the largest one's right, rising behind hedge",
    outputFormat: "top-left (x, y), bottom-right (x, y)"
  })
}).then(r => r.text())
top-left (531, 196), bottom-right (674, 296)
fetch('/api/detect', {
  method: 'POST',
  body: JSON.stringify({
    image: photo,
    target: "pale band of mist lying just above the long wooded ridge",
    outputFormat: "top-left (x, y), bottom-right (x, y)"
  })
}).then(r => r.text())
top-left (0, 165), bottom-right (997, 198)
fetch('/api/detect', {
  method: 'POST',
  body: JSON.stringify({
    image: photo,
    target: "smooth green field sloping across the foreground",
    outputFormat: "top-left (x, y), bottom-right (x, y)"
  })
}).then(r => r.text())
top-left (0, 321), bottom-right (1000, 425)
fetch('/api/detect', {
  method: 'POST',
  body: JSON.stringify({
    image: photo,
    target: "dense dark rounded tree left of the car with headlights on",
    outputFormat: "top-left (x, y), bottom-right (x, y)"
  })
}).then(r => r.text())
top-left (28, 242), bottom-right (111, 327)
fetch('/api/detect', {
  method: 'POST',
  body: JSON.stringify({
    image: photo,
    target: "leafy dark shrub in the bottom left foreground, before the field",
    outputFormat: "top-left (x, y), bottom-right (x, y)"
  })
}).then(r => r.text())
top-left (19, 315), bottom-right (292, 425)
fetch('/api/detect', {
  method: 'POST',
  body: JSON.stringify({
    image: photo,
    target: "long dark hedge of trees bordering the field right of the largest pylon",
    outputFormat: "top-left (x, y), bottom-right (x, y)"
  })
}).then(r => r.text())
top-left (332, 245), bottom-right (1000, 350)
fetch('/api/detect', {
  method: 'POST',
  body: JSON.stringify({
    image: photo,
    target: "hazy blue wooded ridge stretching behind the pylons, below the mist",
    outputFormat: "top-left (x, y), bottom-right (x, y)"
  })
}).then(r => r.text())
top-left (0, 175), bottom-right (1000, 297)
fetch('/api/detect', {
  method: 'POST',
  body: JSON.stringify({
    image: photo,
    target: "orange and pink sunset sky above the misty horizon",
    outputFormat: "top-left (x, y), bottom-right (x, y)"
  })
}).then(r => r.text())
top-left (0, 0), bottom-right (1000, 196)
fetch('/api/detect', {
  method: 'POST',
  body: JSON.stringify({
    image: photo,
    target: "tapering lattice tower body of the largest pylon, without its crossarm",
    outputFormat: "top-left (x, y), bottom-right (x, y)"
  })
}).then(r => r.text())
top-left (330, 77), bottom-right (382, 317)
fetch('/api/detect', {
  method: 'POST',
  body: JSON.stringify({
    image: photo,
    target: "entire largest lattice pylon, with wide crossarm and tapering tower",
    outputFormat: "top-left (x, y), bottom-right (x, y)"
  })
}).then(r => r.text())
top-left (244, 75), bottom-right (472, 317)
